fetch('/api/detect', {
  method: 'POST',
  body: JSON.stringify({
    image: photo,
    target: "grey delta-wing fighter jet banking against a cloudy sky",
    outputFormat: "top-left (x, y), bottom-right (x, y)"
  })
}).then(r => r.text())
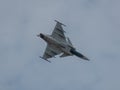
top-left (37, 20), bottom-right (89, 62)
